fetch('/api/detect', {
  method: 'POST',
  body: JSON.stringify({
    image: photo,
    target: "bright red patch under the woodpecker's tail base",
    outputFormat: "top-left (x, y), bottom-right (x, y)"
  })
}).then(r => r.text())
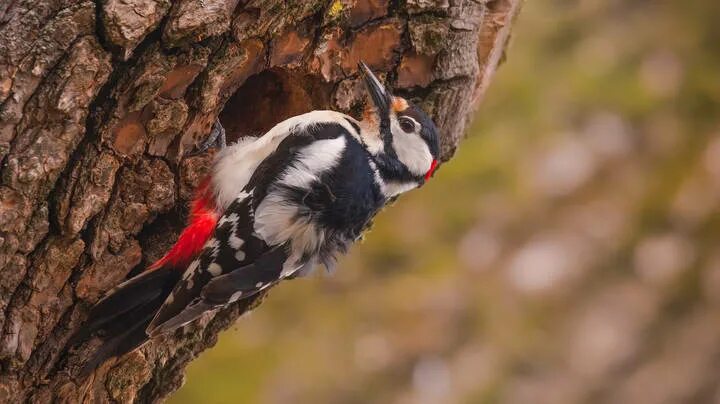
top-left (148, 179), bottom-right (218, 270)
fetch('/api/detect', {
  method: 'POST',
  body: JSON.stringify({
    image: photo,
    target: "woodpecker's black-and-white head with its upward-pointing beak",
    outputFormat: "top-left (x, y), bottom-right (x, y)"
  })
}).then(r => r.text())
top-left (358, 62), bottom-right (440, 193)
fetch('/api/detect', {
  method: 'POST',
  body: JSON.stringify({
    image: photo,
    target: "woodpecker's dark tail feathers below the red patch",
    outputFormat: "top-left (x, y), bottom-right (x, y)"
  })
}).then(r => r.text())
top-left (68, 267), bottom-right (181, 376)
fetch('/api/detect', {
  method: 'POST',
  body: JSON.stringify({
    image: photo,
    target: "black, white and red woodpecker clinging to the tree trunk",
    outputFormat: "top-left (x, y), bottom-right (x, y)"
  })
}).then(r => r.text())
top-left (74, 62), bottom-right (439, 371)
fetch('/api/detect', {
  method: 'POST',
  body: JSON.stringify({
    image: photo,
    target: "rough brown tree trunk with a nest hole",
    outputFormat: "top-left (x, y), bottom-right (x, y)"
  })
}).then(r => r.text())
top-left (0, 0), bottom-right (520, 402)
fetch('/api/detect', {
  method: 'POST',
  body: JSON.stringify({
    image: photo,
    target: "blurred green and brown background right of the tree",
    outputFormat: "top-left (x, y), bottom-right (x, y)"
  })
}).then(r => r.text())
top-left (169, 0), bottom-right (720, 404)
